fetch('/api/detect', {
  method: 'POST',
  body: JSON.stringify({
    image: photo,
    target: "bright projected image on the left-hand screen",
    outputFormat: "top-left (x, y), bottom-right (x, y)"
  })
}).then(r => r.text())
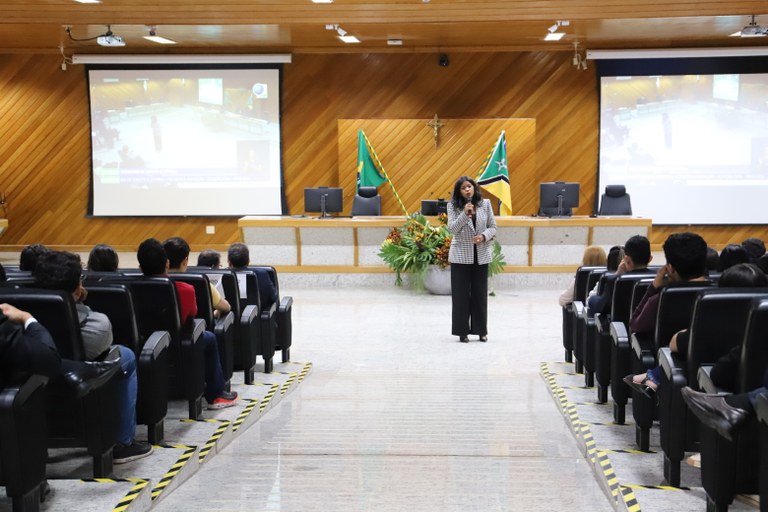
top-left (89, 69), bottom-right (282, 216)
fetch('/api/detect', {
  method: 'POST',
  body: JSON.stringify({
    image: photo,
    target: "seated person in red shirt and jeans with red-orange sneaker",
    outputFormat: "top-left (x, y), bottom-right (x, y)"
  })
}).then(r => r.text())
top-left (137, 238), bottom-right (237, 409)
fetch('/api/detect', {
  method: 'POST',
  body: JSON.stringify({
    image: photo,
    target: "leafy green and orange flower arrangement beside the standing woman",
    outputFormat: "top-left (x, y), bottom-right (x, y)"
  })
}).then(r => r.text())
top-left (379, 213), bottom-right (453, 286)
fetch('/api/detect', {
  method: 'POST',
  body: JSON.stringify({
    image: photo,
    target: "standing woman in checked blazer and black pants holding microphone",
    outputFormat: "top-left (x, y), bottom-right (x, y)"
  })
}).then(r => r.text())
top-left (448, 176), bottom-right (496, 343)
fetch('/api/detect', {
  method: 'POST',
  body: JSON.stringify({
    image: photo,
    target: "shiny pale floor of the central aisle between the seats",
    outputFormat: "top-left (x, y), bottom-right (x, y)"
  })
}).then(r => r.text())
top-left (153, 287), bottom-right (612, 512)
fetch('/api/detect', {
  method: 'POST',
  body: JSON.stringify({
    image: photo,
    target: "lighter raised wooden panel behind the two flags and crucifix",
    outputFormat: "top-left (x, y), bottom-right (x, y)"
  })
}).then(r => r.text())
top-left (338, 119), bottom-right (536, 215)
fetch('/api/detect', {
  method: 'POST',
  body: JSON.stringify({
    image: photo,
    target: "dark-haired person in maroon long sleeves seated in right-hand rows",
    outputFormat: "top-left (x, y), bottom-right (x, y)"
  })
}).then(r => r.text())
top-left (624, 233), bottom-right (708, 396)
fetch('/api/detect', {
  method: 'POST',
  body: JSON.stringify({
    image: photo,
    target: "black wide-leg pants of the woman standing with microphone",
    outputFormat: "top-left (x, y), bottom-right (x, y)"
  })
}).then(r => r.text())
top-left (451, 263), bottom-right (488, 336)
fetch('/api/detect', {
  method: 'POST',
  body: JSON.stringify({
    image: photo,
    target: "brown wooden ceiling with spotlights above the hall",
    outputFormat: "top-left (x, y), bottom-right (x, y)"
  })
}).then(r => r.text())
top-left (0, 0), bottom-right (768, 55)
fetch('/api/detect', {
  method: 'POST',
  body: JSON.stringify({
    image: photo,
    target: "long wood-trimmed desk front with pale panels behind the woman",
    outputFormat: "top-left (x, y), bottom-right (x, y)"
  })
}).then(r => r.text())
top-left (238, 216), bottom-right (651, 273)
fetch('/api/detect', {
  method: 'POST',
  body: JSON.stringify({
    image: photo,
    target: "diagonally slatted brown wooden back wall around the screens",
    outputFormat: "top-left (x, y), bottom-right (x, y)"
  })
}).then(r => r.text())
top-left (0, 52), bottom-right (768, 252)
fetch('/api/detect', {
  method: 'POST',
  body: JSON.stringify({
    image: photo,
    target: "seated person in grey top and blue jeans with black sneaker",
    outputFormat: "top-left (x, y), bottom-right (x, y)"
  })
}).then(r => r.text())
top-left (33, 251), bottom-right (152, 464)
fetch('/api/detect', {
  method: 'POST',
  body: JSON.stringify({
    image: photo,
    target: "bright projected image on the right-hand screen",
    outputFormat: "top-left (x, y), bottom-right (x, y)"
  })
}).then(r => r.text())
top-left (599, 74), bottom-right (768, 224)
